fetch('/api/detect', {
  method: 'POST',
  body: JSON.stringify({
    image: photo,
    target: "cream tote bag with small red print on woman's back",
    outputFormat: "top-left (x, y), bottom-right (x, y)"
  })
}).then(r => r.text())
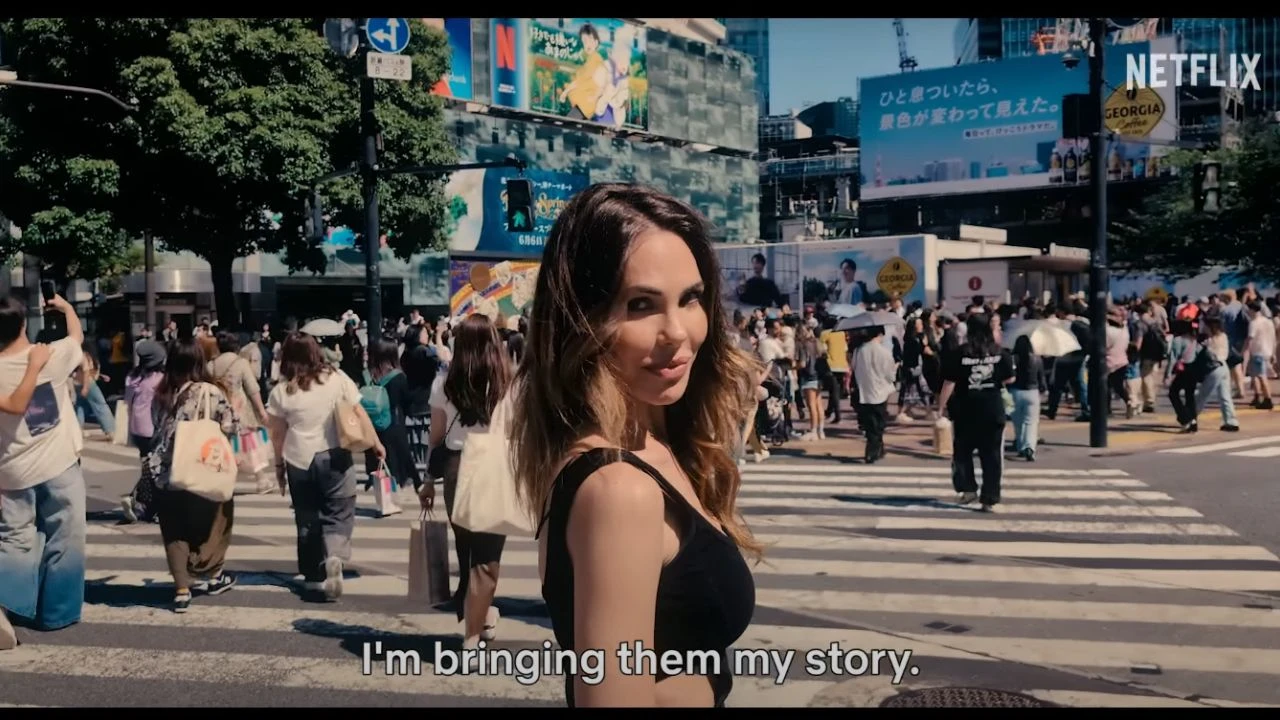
top-left (169, 383), bottom-right (238, 502)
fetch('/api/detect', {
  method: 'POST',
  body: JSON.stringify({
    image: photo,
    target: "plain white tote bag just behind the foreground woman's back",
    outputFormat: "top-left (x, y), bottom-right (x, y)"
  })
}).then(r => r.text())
top-left (449, 391), bottom-right (534, 537)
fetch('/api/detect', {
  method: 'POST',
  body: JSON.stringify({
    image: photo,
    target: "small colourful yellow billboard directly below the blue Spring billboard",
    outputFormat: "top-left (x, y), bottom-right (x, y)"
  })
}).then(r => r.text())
top-left (449, 258), bottom-right (539, 316)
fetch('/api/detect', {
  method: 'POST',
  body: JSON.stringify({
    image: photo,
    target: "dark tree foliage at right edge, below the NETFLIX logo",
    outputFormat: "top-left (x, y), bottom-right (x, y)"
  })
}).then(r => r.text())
top-left (1110, 126), bottom-right (1280, 281)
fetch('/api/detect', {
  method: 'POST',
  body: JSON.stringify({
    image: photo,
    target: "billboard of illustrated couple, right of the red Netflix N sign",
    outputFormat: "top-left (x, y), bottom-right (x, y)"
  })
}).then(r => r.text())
top-left (489, 18), bottom-right (649, 129)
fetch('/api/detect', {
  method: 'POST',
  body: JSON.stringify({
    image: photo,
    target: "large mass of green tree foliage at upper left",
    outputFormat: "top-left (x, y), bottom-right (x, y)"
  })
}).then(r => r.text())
top-left (0, 18), bottom-right (453, 319)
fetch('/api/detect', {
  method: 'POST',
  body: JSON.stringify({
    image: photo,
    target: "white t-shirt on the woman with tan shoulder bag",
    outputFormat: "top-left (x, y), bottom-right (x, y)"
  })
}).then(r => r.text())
top-left (266, 370), bottom-right (360, 470)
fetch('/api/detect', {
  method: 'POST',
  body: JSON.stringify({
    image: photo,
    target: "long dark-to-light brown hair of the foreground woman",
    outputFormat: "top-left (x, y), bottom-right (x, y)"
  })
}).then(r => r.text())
top-left (509, 183), bottom-right (762, 557)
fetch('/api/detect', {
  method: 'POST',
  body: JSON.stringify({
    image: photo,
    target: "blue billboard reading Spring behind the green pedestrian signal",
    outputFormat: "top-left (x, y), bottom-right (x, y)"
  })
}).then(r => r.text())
top-left (444, 168), bottom-right (588, 258)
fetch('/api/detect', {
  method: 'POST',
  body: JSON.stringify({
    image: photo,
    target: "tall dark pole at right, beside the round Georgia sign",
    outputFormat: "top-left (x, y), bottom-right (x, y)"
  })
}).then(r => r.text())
top-left (1088, 18), bottom-right (1111, 447)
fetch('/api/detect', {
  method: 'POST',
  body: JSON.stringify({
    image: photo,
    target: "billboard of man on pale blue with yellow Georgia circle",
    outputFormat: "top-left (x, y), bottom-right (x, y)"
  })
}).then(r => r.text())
top-left (800, 234), bottom-right (927, 305)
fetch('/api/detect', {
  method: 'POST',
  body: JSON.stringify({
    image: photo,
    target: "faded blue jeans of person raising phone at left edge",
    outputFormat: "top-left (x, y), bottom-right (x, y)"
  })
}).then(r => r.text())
top-left (0, 461), bottom-right (87, 630)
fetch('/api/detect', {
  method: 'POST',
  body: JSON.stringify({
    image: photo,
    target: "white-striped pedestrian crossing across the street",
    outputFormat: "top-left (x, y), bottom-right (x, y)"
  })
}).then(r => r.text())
top-left (0, 457), bottom-right (1280, 707)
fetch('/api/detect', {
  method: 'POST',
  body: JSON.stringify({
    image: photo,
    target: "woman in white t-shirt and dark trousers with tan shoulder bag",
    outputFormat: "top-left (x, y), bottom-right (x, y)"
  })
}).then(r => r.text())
top-left (266, 333), bottom-right (387, 601)
